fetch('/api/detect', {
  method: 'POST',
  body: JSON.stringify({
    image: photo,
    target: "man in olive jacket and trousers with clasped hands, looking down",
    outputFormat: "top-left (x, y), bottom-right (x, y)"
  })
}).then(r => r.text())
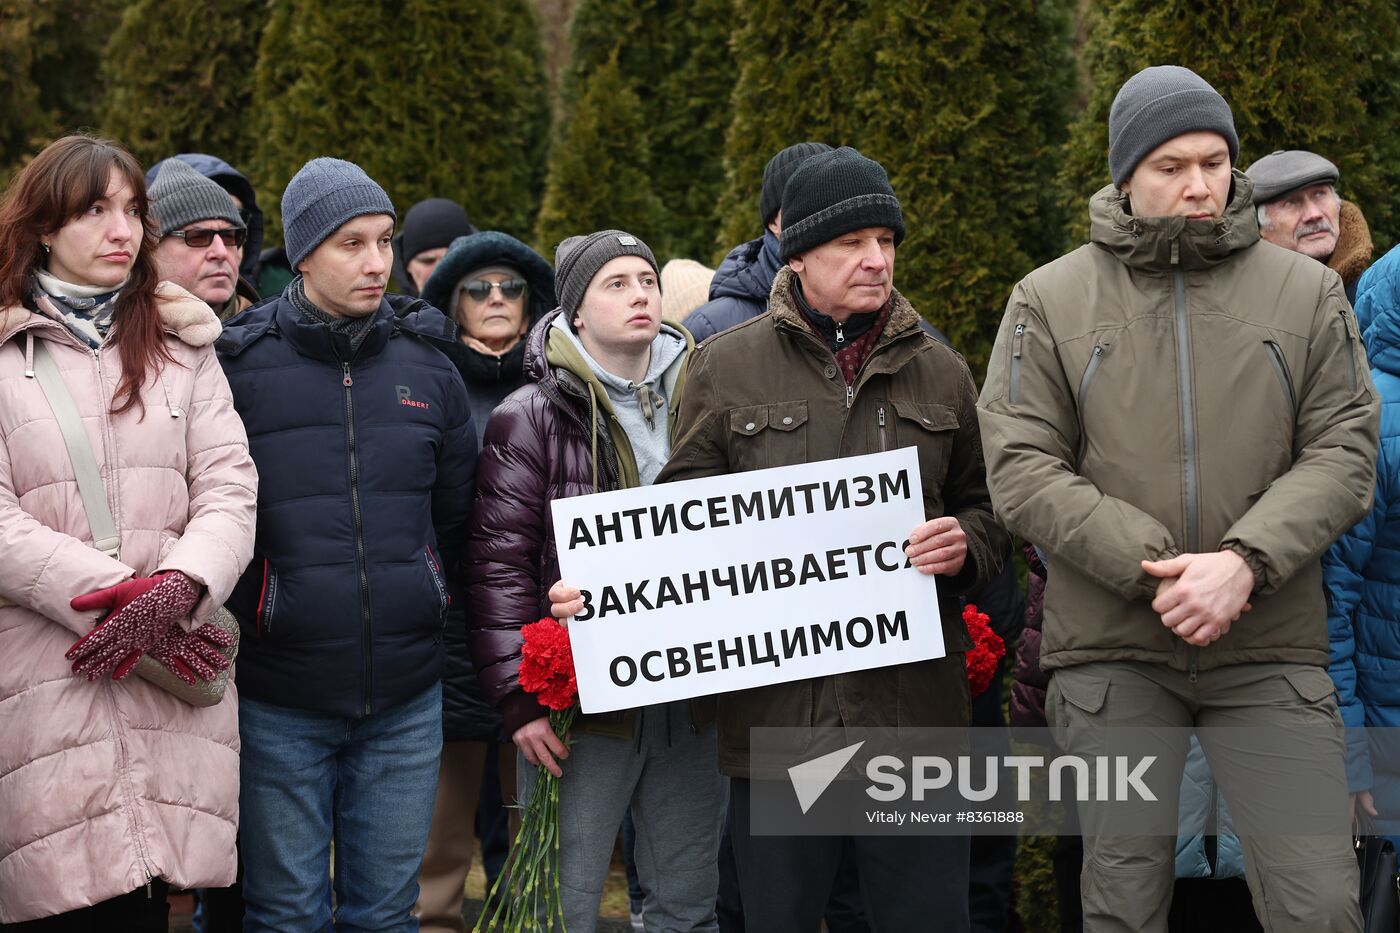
top-left (979, 66), bottom-right (1378, 933)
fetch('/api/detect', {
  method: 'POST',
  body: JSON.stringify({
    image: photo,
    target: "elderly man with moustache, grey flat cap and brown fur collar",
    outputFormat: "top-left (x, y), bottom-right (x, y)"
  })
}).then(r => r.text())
top-left (1245, 148), bottom-right (1375, 303)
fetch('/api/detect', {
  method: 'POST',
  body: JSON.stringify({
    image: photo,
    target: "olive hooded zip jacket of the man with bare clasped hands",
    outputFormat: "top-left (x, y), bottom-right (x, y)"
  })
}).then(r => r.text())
top-left (979, 172), bottom-right (1379, 672)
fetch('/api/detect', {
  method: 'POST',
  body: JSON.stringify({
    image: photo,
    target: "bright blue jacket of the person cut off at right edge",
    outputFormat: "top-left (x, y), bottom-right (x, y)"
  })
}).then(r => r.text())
top-left (1322, 243), bottom-right (1400, 801)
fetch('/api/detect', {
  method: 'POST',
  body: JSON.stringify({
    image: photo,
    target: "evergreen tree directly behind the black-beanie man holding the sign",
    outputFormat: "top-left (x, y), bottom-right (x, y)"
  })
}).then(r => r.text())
top-left (720, 0), bottom-right (1074, 375)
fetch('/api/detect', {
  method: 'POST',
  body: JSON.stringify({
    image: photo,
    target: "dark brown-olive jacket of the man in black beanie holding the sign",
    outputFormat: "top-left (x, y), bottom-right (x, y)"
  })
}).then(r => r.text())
top-left (657, 266), bottom-right (1009, 778)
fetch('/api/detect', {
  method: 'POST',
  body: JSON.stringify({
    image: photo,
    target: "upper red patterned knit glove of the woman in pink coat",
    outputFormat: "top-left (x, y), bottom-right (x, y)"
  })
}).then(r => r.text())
top-left (64, 572), bottom-right (199, 681)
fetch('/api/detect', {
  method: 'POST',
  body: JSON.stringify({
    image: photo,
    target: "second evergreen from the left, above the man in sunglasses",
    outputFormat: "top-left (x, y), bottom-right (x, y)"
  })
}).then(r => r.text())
top-left (102, 0), bottom-right (267, 167)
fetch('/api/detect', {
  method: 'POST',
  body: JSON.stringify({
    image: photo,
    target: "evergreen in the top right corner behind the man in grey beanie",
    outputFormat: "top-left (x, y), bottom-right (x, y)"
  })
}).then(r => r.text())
top-left (1063, 0), bottom-right (1400, 248)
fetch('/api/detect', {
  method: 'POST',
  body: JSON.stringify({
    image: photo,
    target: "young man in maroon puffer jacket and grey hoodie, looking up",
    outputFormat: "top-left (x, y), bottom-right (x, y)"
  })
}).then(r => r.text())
top-left (465, 230), bottom-right (724, 933)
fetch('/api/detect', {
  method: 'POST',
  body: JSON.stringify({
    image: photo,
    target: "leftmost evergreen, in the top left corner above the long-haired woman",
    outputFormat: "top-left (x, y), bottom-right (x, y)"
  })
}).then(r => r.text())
top-left (0, 0), bottom-right (120, 185)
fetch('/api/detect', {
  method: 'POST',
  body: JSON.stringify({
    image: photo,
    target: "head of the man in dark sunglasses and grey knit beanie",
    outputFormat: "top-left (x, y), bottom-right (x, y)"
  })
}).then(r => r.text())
top-left (148, 158), bottom-right (256, 321)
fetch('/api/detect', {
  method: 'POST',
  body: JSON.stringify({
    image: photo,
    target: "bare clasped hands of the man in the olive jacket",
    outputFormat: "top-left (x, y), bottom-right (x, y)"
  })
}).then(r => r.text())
top-left (1142, 551), bottom-right (1254, 647)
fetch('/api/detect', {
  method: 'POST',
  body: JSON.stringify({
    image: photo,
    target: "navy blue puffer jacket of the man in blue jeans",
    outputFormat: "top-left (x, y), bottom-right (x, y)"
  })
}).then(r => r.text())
top-left (217, 296), bottom-right (476, 717)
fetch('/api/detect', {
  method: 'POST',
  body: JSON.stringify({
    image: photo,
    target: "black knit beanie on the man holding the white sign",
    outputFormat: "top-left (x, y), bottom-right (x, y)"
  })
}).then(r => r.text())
top-left (778, 146), bottom-right (904, 262)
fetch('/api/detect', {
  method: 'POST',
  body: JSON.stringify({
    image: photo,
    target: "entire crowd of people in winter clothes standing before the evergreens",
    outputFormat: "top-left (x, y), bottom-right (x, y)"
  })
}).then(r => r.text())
top-left (0, 66), bottom-right (1400, 933)
